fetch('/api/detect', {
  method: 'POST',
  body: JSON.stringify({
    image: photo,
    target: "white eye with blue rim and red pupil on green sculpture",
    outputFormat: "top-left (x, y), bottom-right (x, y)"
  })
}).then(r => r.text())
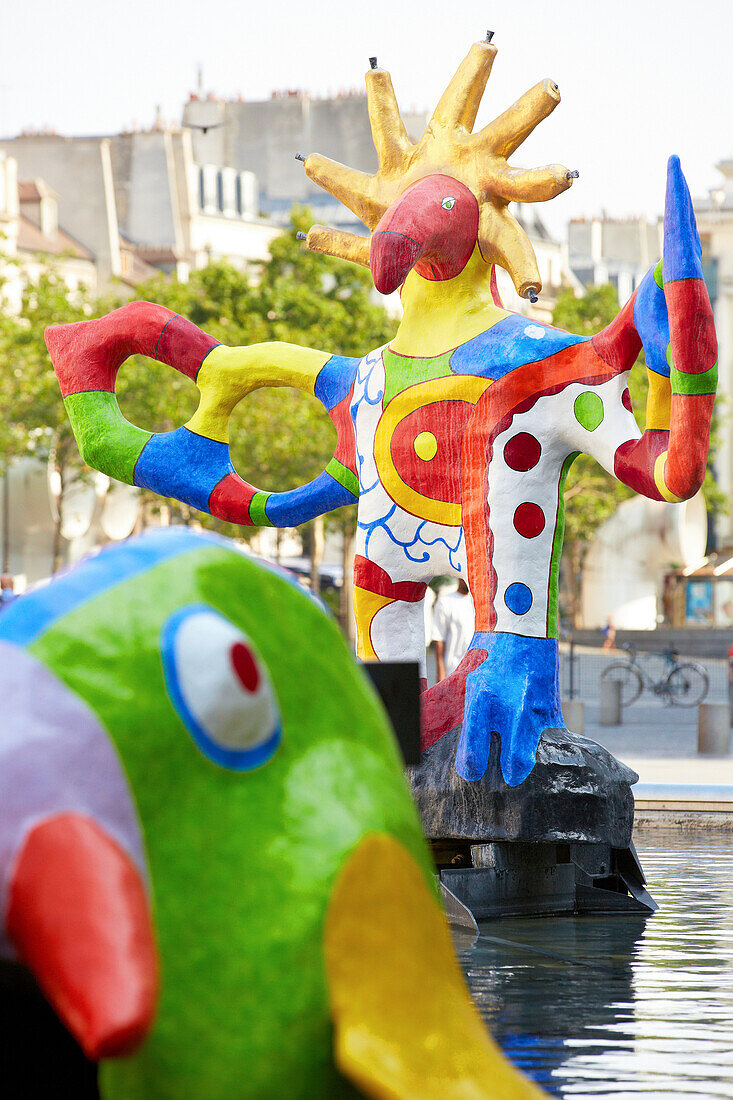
top-left (161, 605), bottom-right (282, 771)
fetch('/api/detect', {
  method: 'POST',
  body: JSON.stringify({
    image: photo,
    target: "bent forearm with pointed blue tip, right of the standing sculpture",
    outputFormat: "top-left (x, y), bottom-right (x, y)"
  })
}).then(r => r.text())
top-left (580, 156), bottom-right (718, 502)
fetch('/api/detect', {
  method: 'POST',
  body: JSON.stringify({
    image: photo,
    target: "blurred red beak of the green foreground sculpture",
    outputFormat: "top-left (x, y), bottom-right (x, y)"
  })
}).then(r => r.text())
top-left (7, 813), bottom-right (157, 1060)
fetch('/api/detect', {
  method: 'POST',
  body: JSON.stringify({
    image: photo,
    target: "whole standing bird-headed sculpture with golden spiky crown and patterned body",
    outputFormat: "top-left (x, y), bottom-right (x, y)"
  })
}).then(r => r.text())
top-left (41, 34), bottom-right (716, 785)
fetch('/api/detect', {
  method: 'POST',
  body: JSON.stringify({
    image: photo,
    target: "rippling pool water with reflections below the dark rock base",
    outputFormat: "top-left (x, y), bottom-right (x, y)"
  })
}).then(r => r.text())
top-left (461, 831), bottom-right (733, 1100)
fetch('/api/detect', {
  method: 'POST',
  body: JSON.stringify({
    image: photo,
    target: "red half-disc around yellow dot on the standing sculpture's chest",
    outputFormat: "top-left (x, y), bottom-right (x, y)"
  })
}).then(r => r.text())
top-left (390, 402), bottom-right (473, 504)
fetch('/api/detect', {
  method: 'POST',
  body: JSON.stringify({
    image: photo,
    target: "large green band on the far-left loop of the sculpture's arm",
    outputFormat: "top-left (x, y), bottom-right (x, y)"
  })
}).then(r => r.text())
top-left (64, 389), bottom-right (152, 485)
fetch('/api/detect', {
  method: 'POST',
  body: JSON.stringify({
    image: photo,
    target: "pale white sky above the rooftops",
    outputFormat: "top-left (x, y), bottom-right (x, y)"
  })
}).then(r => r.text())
top-left (0, 0), bottom-right (733, 232)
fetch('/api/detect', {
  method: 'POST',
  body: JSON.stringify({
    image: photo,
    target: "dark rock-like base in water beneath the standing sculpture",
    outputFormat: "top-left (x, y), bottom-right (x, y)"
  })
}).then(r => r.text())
top-left (407, 729), bottom-right (656, 920)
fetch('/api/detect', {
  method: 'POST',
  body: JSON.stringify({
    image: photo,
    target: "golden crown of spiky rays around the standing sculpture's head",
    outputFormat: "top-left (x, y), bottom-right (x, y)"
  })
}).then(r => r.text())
top-left (305, 35), bottom-right (577, 297)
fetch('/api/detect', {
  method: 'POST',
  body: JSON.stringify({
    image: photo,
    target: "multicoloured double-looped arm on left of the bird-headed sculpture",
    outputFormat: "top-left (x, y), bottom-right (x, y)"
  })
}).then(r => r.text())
top-left (46, 301), bottom-right (359, 527)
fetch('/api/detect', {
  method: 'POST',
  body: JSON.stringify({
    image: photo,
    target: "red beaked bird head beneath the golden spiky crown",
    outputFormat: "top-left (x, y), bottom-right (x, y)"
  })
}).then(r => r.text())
top-left (370, 175), bottom-right (479, 294)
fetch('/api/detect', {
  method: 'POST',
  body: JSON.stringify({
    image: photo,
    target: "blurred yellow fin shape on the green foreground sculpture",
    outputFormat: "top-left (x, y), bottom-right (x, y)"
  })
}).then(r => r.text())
top-left (324, 833), bottom-right (546, 1100)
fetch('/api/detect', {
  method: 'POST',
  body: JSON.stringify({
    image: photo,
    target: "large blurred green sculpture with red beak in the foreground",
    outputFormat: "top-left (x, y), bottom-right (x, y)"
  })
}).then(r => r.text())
top-left (0, 529), bottom-right (544, 1100)
